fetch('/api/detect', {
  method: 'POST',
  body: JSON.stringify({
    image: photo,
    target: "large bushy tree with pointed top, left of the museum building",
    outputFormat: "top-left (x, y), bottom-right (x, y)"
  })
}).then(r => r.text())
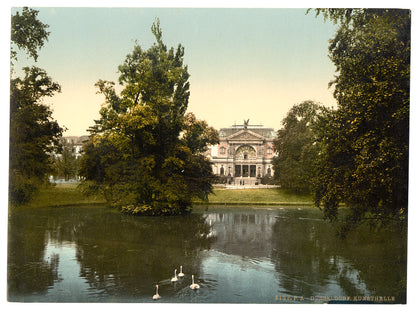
top-left (80, 20), bottom-right (219, 215)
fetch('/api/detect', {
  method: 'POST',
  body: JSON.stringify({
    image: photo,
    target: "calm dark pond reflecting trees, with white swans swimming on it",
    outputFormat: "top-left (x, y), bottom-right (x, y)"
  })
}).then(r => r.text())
top-left (8, 206), bottom-right (407, 304)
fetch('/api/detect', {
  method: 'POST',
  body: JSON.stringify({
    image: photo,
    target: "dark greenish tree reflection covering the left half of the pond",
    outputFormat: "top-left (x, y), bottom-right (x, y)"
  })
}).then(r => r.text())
top-left (8, 207), bottom-right (212, 300)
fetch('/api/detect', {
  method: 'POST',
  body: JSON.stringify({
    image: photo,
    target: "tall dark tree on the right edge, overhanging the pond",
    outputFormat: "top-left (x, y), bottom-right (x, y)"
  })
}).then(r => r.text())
top-left (308, 9), bottom-right (410, 231)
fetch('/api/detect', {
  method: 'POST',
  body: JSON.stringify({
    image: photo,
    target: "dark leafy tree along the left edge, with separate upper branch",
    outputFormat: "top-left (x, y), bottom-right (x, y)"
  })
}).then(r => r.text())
top-left (9, 8), bottom-right (63, 205)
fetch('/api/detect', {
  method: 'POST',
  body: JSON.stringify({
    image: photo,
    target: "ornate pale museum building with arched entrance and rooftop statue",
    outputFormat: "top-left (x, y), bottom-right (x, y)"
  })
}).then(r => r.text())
top-left (207, 120), bottom-right (276, 185)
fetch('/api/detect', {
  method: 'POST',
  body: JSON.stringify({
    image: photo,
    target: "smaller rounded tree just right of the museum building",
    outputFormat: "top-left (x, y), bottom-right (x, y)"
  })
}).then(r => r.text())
top-left (273, 101), bottom-right (326, 192)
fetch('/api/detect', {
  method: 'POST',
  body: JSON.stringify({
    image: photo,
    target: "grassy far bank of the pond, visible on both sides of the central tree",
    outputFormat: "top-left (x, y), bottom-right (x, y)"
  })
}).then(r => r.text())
top-left (16, 183), bottom-right (313, 208)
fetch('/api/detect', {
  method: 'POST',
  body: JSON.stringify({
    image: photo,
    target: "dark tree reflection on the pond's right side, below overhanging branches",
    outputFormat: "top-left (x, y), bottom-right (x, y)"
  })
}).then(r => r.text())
top-left (272, 209), bottom-right (406, 303)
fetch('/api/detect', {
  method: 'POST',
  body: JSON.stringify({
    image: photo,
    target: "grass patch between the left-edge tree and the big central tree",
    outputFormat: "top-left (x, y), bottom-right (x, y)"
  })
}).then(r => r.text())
top-left (20, 184), bottom-right (105, 208)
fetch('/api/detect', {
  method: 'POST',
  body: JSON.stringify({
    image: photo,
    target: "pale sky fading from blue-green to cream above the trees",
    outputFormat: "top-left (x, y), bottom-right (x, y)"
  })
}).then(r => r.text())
top-left (12, 7), bottom-right (342, 136)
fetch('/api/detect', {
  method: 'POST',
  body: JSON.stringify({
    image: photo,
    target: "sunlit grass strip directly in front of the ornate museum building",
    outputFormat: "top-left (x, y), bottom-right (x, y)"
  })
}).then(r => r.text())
top-left (195, 188), bottom-right (312, 205)
